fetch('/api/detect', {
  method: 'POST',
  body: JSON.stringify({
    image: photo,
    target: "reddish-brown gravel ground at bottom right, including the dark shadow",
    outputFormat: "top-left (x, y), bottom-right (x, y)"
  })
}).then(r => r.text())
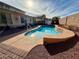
top-left (26, 35), bottom-right (79, 59)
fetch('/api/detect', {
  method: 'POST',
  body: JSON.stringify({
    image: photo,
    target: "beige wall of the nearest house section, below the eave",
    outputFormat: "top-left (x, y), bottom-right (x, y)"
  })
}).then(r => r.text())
top-left (0, 10), bottom-right (25, 27)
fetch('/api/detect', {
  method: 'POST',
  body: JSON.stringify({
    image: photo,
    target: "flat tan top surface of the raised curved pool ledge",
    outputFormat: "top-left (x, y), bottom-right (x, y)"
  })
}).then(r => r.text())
top-left (45, 27), bottom-right (75, 39)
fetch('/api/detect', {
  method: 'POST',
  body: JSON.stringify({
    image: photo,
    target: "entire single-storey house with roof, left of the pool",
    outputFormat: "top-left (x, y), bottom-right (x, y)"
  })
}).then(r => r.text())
top-left (0, 2), bottom-right (44, 27)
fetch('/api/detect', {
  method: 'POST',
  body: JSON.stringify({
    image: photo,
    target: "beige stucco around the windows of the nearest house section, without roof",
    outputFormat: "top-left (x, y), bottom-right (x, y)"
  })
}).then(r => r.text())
top-left (0, 9), bottom-right (25, 27)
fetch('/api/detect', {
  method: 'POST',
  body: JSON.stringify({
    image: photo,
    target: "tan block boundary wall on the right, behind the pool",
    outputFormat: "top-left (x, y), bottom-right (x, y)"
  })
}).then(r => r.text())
top-left (59, 13), bottom-right (79, 27)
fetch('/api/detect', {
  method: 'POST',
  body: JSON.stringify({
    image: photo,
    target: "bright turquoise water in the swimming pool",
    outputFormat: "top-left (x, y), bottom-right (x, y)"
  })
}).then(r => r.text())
top-left (25, 26), bottom-right (60, 39)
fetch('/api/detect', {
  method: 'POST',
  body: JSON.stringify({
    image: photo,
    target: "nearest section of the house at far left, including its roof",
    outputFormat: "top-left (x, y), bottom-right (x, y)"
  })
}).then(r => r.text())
top-left (0, 2), bottom-right (25, 27)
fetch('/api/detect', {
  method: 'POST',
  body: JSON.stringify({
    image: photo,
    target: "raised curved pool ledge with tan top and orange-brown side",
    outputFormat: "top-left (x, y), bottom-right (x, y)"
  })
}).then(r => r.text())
top-left (44, 25), bottom-right (75, 43)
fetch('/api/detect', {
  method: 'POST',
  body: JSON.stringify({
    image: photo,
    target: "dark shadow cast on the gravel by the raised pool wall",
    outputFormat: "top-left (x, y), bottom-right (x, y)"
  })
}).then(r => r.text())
top-left (44, 36), bottom-right (79, 55)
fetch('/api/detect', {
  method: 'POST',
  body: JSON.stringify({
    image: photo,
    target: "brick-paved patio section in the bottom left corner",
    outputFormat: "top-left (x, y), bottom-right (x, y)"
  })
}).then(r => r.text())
top-left (0, 44), bottom-right (27, 59)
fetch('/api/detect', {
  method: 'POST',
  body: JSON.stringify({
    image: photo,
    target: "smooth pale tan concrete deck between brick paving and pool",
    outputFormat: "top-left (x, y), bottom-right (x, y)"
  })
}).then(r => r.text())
top-left (1, 26), bottom-right (75, 52)
